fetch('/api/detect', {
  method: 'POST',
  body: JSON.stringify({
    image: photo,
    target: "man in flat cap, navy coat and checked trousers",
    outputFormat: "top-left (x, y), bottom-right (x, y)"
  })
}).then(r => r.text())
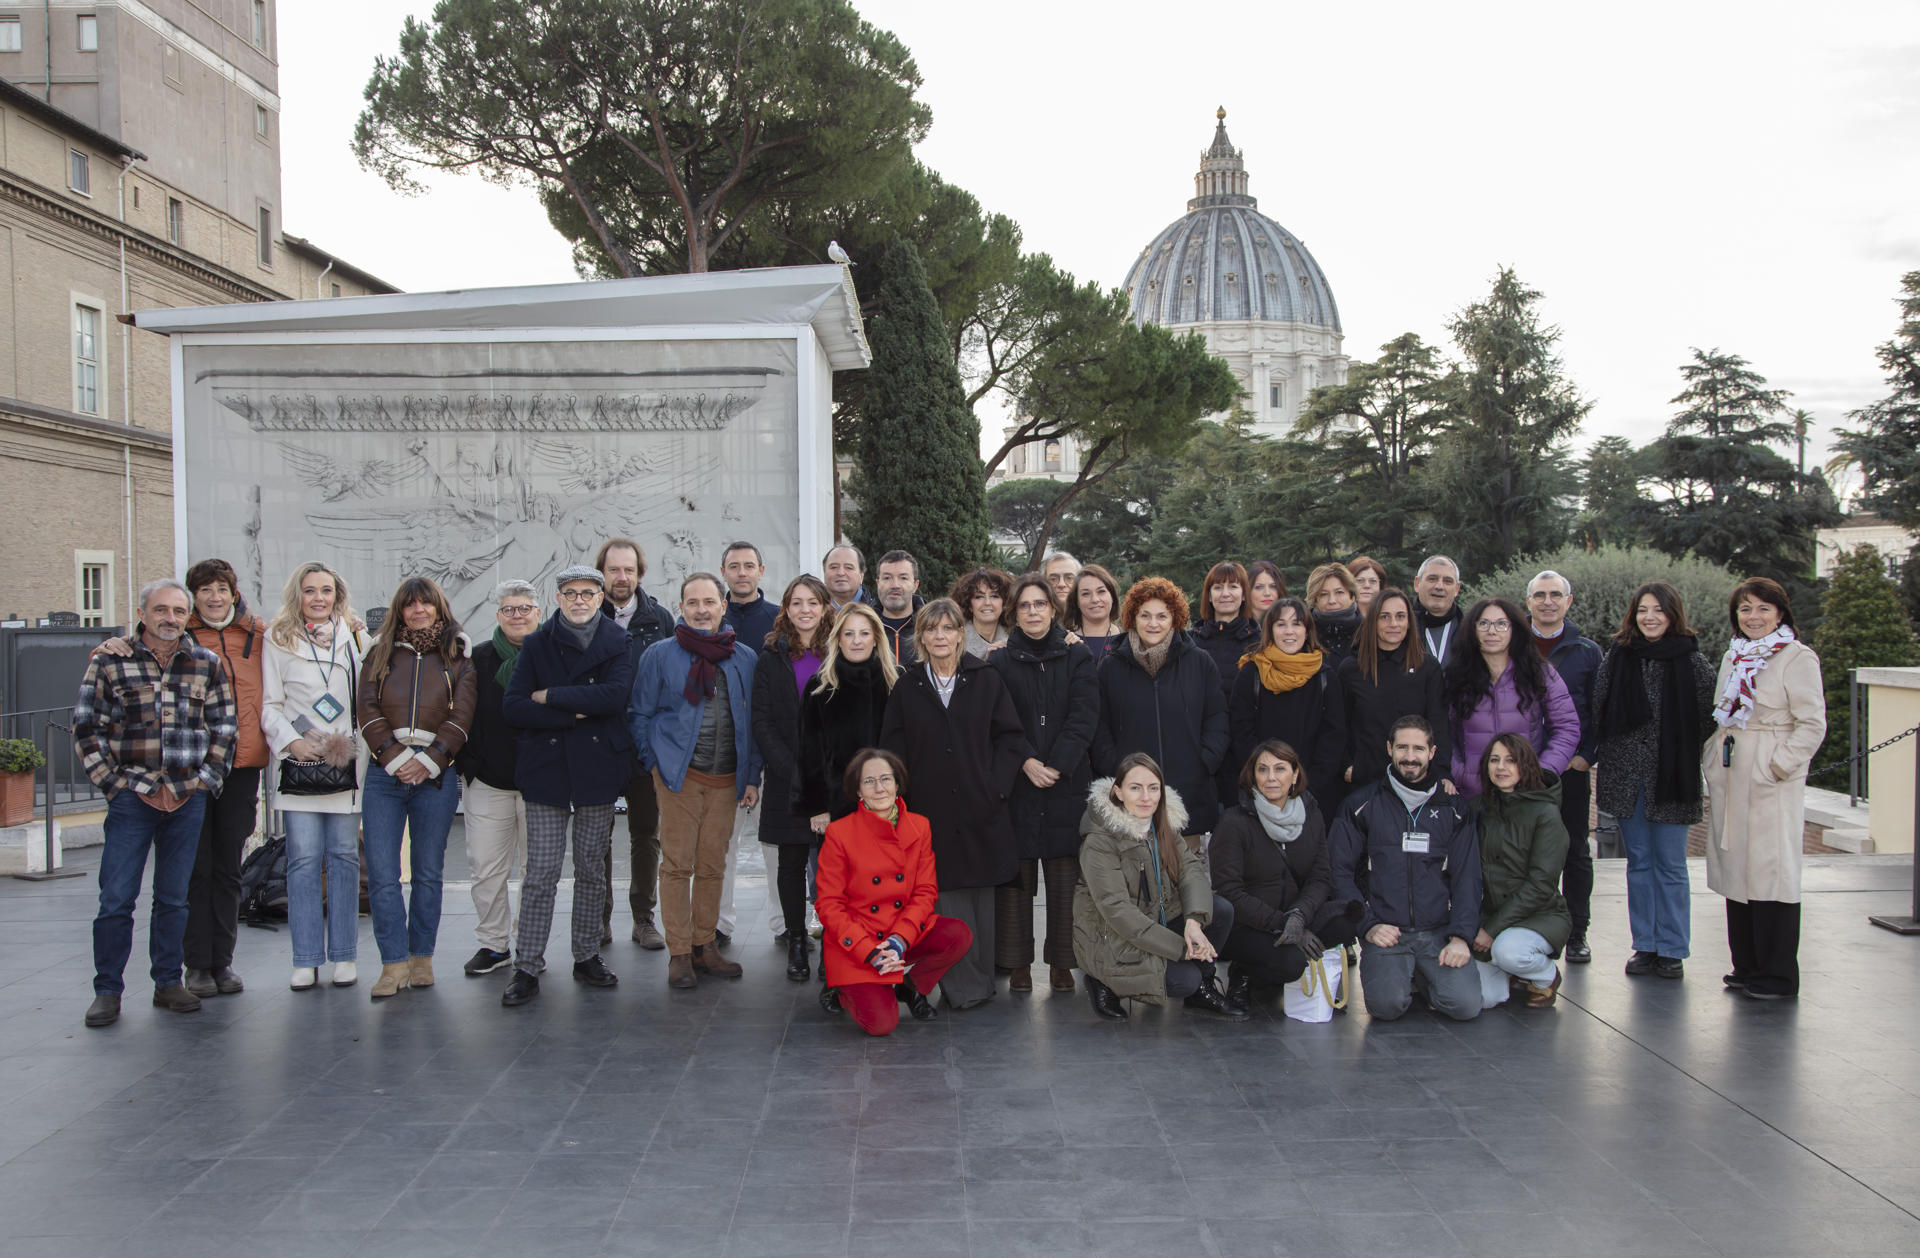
top-left (499, 565), bottom-right (634, 1008)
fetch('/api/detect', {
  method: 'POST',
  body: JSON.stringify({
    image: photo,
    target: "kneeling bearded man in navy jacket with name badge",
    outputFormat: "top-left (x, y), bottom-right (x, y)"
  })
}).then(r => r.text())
top-left (1331, 716), bottom-right (1480, 1022)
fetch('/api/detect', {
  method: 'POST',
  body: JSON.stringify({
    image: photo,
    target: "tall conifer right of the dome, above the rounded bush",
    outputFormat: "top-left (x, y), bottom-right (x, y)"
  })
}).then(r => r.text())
top-left (1421, 267), bottom-right (1592, 574)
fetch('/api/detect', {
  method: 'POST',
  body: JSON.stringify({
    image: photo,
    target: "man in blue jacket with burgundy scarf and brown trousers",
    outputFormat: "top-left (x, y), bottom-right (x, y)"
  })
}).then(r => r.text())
top-left (626, 572), bottom-right (760, 987)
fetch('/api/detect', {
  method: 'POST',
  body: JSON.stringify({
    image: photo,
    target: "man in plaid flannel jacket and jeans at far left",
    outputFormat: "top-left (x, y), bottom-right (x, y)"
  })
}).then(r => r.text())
top-left (73, 580), bottom-right (238, 1026)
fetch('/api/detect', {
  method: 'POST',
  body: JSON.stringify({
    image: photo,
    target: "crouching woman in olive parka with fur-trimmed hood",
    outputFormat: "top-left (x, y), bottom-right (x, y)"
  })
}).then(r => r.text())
top-left (1073, 751), bottom-right (1246, 1020)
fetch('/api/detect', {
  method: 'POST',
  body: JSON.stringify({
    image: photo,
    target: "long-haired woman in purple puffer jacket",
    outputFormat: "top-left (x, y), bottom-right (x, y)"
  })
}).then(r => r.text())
top-left (1446, 599), bottom-right (1580, 795)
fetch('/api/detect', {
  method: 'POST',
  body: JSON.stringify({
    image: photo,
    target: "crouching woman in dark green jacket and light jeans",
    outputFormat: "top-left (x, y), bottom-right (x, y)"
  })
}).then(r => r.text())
top-left (1473, 734), bottom-right (1572, 1008)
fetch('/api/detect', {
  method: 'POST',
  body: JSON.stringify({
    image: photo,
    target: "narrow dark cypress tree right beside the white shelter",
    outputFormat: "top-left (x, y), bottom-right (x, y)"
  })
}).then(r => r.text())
top-left (847, 240), bottom-right (989, 592)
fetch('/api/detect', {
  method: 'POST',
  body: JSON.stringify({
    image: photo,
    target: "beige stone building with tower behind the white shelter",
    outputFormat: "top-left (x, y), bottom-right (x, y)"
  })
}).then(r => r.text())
top-left (0, 0), bottom-right (394, 624)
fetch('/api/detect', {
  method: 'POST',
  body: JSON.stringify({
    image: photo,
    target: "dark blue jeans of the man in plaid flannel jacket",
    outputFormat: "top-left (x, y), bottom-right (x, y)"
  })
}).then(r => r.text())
top-left (94, 789), bottom-right (207, 995)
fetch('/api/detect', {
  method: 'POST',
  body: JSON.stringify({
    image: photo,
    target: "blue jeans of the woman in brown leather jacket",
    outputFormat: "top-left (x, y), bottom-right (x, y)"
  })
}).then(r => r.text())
top-left (361, 764), bottom-right (461, 966)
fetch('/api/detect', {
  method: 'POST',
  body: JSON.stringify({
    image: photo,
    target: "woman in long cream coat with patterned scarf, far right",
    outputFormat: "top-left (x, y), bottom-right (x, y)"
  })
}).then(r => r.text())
top-left (1701, 576), bottom-right (1826, 1001)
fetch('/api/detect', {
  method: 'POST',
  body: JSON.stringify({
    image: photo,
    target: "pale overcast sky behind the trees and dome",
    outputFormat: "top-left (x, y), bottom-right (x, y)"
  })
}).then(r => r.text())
top-left (276, 0), bottom-right (1920, 483)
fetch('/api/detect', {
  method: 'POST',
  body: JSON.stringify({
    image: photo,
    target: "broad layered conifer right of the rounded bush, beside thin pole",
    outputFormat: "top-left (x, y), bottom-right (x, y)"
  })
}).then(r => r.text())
top-left (1638, 350), bottom-right (1839, 583)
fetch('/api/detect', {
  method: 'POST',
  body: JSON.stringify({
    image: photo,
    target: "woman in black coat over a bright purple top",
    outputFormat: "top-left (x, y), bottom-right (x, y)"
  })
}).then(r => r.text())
top-left (753, 576), bottom-right (833, 981)
